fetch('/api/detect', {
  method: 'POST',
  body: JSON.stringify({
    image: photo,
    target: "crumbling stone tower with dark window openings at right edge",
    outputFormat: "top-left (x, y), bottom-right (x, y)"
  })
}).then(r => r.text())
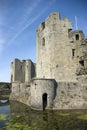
top-left (69, 30), bottom-right (87, 76)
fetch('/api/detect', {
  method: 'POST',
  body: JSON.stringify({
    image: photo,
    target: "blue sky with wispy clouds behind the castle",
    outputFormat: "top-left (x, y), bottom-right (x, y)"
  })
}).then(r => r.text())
top-left (0, 0), bottom-right (87, 82)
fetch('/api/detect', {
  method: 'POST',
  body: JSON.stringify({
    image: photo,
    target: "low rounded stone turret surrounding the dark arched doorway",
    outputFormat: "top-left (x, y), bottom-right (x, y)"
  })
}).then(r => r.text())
top-left (31, 79), bottom-right (56, 110)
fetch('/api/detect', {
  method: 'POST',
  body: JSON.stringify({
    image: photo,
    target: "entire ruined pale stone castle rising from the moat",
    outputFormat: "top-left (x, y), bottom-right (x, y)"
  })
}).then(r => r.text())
top-left (10, 12), bottom-right (87, 110)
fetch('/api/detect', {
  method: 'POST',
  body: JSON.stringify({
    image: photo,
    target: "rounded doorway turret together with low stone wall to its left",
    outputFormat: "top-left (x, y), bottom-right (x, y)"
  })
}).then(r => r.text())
top-left (10, 79), bottom-right (56, 110)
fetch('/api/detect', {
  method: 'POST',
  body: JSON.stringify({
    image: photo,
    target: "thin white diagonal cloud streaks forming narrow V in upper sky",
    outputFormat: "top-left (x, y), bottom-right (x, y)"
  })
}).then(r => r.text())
top-left (8, 0), bottom-right (53, 44)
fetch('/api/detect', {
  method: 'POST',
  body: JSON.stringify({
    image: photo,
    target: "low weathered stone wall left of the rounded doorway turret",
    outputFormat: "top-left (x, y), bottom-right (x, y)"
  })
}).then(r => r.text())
top-left (10, 82), bottom-right (31, 106)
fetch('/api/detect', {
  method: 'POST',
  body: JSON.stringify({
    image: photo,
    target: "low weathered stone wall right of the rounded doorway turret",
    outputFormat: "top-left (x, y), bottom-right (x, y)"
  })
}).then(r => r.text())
top-left (54, 82), bottom-right (87, 109)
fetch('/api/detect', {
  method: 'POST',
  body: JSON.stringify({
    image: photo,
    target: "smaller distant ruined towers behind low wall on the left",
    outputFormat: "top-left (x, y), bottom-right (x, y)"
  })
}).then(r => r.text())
top-left (11, 59), bottom-right (36, 83)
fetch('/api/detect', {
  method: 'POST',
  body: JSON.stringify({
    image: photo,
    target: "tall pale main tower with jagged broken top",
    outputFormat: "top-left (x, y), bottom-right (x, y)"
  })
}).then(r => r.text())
top-left (37, 13), bottom-right (76, 81)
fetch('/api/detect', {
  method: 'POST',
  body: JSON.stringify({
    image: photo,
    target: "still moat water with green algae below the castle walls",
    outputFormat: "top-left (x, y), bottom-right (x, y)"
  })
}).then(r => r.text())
top-left (0, 101), bottom-right (87, 130)
